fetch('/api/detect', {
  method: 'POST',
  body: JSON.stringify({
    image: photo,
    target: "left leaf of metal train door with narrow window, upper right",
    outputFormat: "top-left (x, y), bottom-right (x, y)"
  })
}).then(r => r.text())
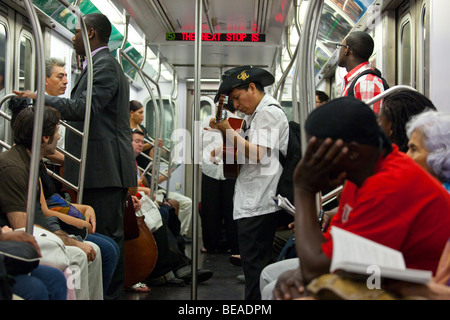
top-left (396, 0), bottom-right (429, 95)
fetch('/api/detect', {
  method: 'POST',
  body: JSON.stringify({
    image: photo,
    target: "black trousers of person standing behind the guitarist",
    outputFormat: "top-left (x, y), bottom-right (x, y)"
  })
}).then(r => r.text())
top-left (200, 174), bottom-right (239, 254)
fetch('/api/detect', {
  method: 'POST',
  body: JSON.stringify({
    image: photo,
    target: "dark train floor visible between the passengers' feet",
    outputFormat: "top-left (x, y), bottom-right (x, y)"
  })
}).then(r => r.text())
top-left (125, 241), bottom-right (244, 300)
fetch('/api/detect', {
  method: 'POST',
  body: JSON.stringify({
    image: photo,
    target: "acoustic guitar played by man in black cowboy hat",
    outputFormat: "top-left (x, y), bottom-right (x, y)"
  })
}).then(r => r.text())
top-left (216, 94), bottom-right (245, 179)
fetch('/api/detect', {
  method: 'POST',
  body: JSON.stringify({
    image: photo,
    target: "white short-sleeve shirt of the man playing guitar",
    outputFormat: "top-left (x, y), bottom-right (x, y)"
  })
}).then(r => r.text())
top-left (233, 94), bottom-right (289, 220)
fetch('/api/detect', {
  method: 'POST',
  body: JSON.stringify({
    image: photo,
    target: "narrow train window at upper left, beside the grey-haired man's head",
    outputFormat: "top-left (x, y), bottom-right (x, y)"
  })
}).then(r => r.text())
top-left (19, 30), bottom-right (35, 90)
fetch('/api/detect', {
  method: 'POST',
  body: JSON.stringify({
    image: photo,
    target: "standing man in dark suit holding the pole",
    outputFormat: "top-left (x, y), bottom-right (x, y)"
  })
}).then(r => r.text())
top-left (16, 13), bottom-right (136, 298)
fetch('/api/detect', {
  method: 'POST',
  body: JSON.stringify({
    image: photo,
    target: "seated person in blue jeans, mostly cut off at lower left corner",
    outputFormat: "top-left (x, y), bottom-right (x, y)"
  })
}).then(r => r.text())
top-left (0, 226), bottom-right (67, 300)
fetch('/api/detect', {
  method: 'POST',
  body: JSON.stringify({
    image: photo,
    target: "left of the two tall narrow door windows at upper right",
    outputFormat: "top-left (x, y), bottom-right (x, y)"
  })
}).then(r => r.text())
top-left (398, 14), bottom-right (413, 86)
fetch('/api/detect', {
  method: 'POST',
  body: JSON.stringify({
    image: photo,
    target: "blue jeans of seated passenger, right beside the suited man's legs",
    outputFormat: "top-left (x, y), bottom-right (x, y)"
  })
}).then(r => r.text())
top-left (86, 233), bottom-right (120, 296)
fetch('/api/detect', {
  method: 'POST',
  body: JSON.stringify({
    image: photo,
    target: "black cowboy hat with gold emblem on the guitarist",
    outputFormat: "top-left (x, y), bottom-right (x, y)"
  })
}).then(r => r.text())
top-left (214, 66), bottom-right (275, 102)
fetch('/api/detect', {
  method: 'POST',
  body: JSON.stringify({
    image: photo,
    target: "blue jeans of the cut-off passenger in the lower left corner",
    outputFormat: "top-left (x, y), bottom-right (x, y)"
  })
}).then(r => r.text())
top-left (13, 265), bottom-right (67, 300)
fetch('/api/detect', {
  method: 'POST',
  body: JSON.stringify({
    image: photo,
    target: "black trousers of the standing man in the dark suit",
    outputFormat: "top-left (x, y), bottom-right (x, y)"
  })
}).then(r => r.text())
top-left (83, 187), bottom-right (128, 299)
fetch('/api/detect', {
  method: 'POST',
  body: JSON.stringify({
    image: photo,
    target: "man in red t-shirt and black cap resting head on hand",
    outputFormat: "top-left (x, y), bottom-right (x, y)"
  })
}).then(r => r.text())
top-left (274, 97), bottom-right (450, 299)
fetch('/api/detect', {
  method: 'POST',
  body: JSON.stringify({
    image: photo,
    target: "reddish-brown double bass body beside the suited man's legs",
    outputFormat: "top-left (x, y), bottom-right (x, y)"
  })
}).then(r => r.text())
top-left (123, 193), bottom-right (158, 288)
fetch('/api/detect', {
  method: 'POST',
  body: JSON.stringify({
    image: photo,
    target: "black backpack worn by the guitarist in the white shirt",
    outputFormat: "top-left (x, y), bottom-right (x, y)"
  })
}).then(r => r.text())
top-left (276, 121), bottom-right (302, 204)
